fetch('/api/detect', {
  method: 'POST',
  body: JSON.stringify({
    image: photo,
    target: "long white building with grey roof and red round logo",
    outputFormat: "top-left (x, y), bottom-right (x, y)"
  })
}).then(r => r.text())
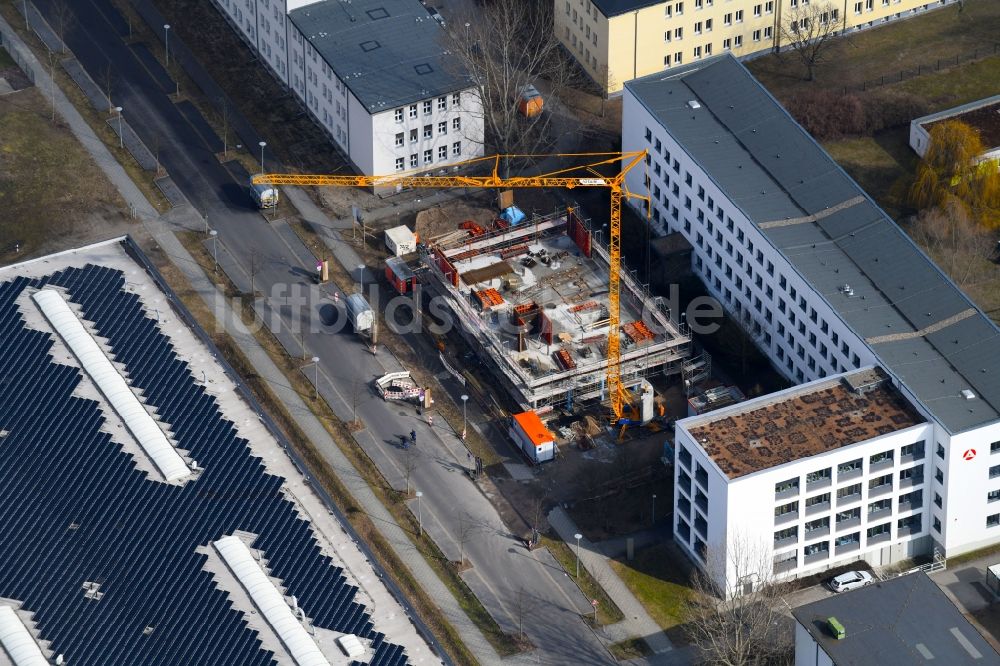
top-left (622, 54), bottom-right (1000, 588)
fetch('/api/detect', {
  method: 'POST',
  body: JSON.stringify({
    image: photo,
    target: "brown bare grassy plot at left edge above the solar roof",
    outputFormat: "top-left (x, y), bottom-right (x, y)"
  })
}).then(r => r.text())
top-left (0, 82), bottom-right (135, 262)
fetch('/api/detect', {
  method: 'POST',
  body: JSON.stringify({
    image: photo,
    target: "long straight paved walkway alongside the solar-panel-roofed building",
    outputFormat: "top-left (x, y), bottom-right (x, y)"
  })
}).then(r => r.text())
top-left (0, 17), bottom-right (508, 664)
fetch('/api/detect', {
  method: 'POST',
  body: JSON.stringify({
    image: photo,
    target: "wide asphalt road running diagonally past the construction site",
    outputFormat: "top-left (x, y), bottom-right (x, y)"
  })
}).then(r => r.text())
top-left (43, 0), bottom-right (611, 664)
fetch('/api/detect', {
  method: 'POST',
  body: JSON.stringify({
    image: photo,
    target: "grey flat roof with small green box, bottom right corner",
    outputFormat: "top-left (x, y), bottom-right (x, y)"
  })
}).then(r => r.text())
top-left (792, 572), bottom-right (1000, 666)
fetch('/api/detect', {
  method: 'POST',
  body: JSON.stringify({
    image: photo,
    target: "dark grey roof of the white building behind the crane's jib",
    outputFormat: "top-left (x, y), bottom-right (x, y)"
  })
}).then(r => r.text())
top-left (288, 0), bottom-right (469, 113)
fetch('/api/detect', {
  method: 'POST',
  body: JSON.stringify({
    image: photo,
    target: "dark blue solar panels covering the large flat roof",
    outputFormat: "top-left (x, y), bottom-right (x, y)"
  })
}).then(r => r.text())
top-left (0, 239), bottom-right (408, 666)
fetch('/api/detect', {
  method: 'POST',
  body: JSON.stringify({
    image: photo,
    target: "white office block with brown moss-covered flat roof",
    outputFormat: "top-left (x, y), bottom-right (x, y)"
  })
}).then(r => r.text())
top-left (674, 367), bottom-right (933, 590)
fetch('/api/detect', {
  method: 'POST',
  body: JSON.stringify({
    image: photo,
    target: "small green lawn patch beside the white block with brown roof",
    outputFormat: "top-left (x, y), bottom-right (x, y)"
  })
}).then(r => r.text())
top-left (611, 544), bottom-right (692, 630)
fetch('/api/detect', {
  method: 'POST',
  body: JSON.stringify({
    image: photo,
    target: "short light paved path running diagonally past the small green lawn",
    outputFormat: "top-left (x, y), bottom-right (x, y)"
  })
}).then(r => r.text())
top-left (549, 507), bottom-right (674, 654)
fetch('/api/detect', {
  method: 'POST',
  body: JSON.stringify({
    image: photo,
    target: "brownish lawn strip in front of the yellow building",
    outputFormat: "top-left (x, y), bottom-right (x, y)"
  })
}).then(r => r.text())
top-left (747, 0), bottom-right (1000, 99)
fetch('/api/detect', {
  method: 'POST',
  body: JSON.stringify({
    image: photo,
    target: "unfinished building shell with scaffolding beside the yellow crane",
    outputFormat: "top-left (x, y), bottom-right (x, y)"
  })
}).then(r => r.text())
top-left (423, 209), bottom-right (691, 409)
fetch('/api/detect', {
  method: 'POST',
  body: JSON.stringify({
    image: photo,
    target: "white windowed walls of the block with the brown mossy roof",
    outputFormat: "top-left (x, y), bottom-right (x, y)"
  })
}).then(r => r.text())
top-left (674, 370), bottom-right (934, 590)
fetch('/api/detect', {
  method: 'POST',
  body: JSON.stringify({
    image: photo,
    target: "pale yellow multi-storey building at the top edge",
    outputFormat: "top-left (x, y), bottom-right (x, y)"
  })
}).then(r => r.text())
top-left (554, 0), bottom-right (957, 93)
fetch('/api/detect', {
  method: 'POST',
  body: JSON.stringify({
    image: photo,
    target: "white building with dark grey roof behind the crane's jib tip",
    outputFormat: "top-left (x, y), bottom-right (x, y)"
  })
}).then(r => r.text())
top-left (213, 0), bottom-right (483, 174)
